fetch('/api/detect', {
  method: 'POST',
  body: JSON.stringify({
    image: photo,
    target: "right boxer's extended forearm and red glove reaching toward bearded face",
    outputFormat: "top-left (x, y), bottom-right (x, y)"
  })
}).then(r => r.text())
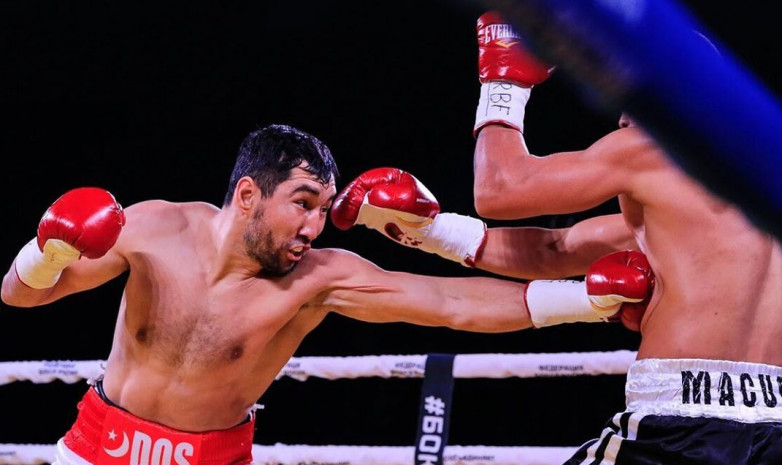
top-left (331, 168), bottom-right (638, 279)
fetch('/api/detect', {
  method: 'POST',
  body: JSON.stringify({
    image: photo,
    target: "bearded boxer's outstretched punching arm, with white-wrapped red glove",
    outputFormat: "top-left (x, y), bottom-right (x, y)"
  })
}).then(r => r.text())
top-left (316, 246), bottom-right (653, 333)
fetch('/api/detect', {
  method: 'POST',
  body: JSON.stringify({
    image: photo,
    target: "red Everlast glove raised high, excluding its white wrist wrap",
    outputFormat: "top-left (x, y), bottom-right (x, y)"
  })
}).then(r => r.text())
top-left (476, 12), bottom-right (553, 87)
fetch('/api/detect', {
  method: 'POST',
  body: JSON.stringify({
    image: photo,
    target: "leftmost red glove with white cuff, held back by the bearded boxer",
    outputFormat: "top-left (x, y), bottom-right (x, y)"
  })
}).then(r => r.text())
top-left (15, 187), bottom-right (125, 289)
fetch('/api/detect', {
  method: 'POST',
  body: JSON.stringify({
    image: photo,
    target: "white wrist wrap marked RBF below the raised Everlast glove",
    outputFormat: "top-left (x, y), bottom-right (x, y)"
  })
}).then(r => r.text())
top-left (473, 81), bottom-right (531, 136)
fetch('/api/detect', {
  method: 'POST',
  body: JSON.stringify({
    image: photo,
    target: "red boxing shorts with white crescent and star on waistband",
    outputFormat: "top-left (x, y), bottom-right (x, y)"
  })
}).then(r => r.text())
top-left (54, 388), bottom-right (255, 465)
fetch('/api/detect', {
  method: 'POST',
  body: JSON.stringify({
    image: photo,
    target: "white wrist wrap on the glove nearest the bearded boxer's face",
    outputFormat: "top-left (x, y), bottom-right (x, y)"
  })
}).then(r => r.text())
top-left (421, 213), bottom-right (486, 267)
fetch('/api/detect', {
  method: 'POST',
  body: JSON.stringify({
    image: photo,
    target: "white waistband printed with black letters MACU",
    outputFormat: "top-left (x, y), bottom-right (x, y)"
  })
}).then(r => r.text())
top-left (625, 359), bottom-right (782, 423)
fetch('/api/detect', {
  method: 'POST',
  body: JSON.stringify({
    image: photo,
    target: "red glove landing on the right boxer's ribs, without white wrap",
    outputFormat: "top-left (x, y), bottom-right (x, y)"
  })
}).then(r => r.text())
top-left (586, 250), bottom-right (654, 331)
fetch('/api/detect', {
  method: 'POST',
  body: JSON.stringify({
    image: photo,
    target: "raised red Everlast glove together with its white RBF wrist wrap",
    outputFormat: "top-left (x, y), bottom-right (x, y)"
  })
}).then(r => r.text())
top-left (473, 12), bottom-right (554, 137)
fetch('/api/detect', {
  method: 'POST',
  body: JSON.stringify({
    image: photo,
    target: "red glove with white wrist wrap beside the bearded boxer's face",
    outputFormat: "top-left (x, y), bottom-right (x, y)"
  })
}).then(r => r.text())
top-left (331, 168), bottom-right (486, 266)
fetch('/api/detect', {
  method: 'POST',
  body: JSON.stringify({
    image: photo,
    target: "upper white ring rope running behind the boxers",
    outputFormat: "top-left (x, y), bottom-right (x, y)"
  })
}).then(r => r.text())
top-left (0, 350), bottom-right (636, 384)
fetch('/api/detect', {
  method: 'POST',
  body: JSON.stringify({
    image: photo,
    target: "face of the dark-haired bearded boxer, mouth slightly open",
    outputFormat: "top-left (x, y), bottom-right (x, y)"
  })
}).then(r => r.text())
top-left (244, 168), bottom-right (336, 276)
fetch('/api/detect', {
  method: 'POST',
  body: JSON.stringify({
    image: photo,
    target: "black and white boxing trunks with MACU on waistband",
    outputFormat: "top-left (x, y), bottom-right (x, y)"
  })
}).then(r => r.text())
top-left (566, 359), bottom-right (782, 465)
